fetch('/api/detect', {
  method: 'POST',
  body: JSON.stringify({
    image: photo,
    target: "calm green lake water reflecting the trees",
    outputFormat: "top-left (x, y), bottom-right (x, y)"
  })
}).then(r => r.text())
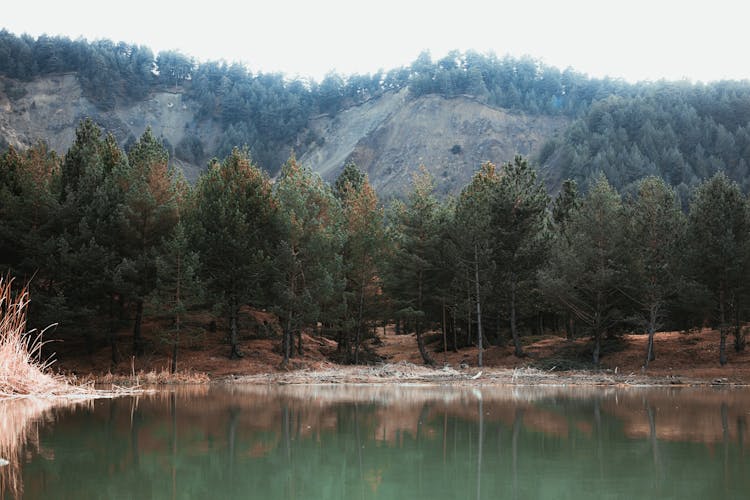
top-left (0, 386), bottom-right (750, 500)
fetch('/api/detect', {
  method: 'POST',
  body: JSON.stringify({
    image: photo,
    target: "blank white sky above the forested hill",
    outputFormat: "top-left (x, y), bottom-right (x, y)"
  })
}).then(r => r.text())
top-left (0, 0), bottom-right (750, 81)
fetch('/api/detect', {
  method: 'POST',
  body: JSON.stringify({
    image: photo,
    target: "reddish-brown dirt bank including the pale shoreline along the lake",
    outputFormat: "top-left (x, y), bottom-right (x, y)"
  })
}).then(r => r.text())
top-left (51, 318), bottom-right (750, 385)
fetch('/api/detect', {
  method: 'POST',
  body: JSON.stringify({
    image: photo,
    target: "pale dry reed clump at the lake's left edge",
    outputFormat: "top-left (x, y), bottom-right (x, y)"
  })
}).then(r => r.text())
top-left (0, 277), bottom-right (93, 398)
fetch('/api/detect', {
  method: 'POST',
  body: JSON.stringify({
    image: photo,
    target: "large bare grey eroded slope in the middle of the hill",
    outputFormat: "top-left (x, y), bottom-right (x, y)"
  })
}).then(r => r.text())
top-left (301, 90), bottom-right (569, 196)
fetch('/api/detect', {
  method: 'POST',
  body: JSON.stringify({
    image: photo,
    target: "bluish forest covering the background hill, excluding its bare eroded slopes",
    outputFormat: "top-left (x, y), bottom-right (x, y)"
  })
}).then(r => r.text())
top-left (0, 30), bottom-right (750, 193)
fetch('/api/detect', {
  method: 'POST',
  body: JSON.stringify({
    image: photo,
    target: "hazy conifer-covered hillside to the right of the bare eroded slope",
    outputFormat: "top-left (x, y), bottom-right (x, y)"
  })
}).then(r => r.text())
top-left (539, 82), bottom-right (750, 195)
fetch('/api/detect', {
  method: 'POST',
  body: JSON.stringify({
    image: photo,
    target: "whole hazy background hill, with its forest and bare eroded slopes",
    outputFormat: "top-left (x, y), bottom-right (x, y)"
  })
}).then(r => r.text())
top-left (0, 30), bottom-right (750, 196)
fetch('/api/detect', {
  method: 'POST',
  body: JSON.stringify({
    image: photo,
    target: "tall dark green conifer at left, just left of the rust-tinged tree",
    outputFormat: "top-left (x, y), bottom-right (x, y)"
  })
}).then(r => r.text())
top-left (55, 119), bottom-right (127, 364)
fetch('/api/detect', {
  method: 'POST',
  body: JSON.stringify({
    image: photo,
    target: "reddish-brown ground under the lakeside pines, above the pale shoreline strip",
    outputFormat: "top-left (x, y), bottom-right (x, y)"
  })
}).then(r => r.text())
top-left (53, 311), bottom-right (750, 384)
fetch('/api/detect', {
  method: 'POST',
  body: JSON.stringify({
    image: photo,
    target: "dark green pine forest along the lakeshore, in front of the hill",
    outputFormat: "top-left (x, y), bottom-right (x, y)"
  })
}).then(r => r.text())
top-left (0, 120), bottom-right (750, 369)
